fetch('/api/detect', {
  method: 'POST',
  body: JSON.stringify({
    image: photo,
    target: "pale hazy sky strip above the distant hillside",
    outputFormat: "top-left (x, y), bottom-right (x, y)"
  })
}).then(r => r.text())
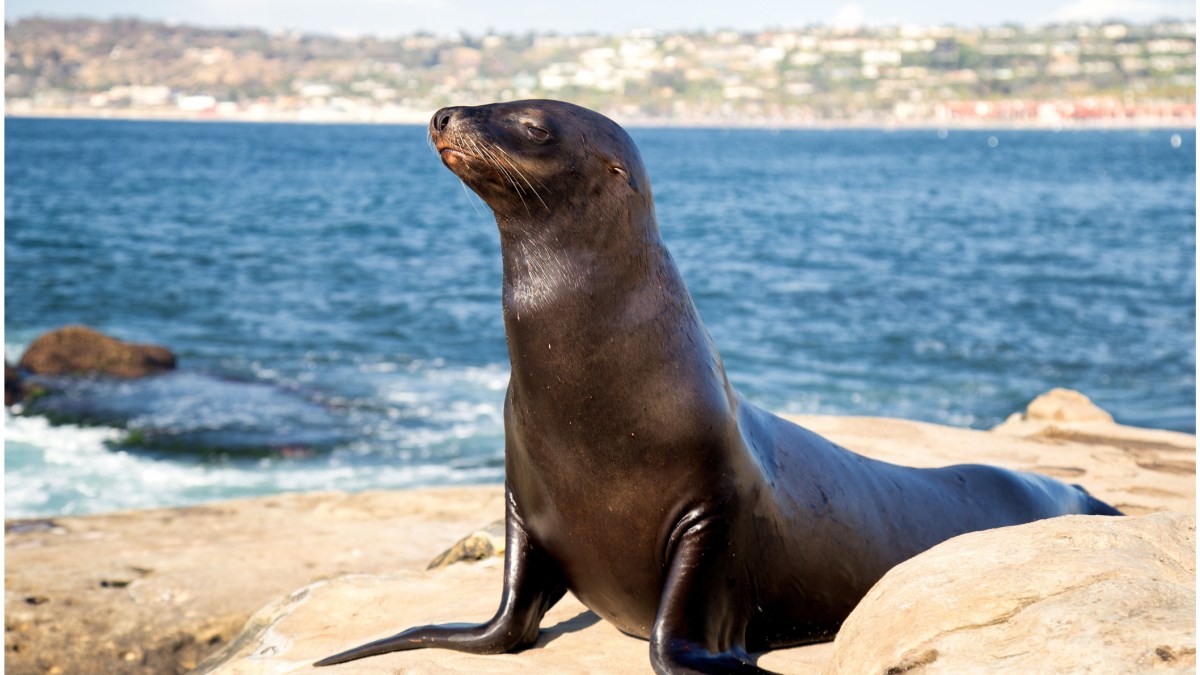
top-left (5, 0), bottom-right (1195, 35)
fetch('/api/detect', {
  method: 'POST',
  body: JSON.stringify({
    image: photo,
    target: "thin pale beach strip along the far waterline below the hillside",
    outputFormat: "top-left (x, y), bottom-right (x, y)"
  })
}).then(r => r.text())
top-left (5, 108), bottom-right (1195, 131)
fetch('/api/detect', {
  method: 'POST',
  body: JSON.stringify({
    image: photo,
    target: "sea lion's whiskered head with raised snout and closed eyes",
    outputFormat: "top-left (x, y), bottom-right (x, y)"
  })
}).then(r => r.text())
top-left (430, 100), bottom-right (653, 221)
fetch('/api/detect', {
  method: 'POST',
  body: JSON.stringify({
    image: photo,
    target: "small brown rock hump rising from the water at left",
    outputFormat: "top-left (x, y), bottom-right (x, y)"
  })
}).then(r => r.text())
top-left (18, 325), bottom-right (175, 377)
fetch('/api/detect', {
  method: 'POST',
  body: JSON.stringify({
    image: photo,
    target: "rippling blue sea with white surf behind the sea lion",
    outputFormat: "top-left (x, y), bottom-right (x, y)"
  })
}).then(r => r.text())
top-left (5, 119), bottom-right (1196, 516)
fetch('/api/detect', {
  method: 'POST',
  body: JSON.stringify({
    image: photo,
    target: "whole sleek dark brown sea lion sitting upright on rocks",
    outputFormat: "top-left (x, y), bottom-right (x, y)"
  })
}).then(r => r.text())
top-left (316, 101), bottom-right (1118, 673)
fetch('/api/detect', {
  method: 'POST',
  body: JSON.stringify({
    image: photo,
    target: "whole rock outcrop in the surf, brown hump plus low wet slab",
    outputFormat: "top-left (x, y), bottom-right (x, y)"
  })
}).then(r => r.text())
top-left (12, 325), bottom-right (349, 458)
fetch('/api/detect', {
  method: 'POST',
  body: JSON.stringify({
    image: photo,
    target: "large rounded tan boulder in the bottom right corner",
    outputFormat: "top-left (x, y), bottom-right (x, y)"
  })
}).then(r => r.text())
top-left (824, 513), bottom-right (1196, 675)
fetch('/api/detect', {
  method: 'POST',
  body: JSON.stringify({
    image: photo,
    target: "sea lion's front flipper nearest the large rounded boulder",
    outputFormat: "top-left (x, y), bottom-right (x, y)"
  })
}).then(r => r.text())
top-left (650, 513), bottom-right (770, 675)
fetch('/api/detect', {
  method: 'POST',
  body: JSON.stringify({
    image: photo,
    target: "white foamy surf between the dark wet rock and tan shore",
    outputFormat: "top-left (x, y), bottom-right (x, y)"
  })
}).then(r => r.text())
top-left (5, 360), bottom-right (509, 516)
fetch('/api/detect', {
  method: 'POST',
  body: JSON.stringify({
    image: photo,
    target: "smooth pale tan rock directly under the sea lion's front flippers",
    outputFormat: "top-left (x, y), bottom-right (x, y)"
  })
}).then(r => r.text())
top-left (196, 558), bottom-right (833, 675)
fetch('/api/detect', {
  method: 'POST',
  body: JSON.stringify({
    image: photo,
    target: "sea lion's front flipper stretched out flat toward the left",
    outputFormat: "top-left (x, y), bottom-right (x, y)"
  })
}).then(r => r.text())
top-left (313, 487), bottom-right (566, 665)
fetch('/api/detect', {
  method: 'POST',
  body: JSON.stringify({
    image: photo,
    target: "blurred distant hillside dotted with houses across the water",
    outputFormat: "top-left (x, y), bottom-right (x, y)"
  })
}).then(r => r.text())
top-left (5, 19), bottom-right (1196, 135)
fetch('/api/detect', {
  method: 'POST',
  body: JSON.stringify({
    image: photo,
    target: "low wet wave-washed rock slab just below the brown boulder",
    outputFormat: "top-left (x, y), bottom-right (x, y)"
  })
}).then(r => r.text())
top-left (24, 371), bottom-right (350, 458)
